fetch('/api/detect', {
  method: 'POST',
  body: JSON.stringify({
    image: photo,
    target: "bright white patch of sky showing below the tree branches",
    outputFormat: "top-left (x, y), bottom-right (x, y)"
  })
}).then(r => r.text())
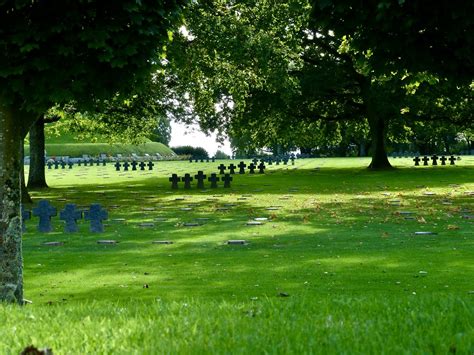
top-left (169, 121), bottom-right (232, 156)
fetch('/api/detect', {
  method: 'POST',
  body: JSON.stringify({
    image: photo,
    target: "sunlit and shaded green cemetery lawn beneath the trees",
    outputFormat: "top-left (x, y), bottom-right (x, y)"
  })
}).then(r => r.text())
top-left (0, 157), bottom-right (474, 354)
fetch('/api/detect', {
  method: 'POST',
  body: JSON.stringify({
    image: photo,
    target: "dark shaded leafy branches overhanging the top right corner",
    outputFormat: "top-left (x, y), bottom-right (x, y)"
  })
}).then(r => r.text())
top-left (312, 0), bottom-right (474, 83)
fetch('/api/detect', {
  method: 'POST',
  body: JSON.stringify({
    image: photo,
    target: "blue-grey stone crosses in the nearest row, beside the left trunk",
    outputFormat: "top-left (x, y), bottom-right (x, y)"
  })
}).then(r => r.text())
top-left (21, 200), bottom-right (108, 233)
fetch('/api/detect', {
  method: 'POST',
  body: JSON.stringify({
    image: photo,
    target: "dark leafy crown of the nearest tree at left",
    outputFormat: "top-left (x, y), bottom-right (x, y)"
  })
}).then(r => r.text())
top-left (0, 0), bottom-right (185, 113)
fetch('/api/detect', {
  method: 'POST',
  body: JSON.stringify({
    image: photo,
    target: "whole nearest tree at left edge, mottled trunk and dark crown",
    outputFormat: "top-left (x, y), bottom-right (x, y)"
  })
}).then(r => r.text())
top-left (0, 0), bottom-right (184, 303)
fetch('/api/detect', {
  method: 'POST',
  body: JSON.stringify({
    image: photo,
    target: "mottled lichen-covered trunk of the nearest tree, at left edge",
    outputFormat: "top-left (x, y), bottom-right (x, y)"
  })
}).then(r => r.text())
top-left (0, 101), bottom-right (34, 304)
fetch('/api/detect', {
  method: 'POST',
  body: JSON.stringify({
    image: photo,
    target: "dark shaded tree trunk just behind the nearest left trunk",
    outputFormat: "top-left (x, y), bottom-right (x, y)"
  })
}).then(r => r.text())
top-left (28, 117), bottom-right (48, 189)
